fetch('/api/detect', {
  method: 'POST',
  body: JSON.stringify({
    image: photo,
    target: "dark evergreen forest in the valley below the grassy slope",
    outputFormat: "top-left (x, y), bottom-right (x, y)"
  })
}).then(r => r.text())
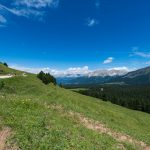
top-left (79, 85), bottom-right (150, 113)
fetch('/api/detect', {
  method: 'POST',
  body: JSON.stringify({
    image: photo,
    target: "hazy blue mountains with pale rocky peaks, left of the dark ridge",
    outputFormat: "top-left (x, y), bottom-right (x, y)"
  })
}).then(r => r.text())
top-left (57, 68), bottom-right (128, 85)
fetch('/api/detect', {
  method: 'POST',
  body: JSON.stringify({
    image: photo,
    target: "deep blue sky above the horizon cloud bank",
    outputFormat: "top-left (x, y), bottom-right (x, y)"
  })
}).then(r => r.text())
top-left (0, 0), bottom-right (150, 74)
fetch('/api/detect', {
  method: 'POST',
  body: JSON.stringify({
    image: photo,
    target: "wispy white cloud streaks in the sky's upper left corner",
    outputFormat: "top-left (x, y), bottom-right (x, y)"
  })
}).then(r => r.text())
top-left (0, 0), bottom-right (59, 23)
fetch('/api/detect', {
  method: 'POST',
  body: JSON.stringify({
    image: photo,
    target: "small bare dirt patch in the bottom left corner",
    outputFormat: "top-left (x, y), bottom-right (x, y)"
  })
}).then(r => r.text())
top-left (0, 128), bottom-right (11, 150)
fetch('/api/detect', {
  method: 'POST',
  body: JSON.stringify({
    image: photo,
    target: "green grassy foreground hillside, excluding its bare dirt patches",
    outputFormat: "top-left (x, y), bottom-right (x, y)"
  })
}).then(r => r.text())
top-left (0, 75), bottom-right (150, 150)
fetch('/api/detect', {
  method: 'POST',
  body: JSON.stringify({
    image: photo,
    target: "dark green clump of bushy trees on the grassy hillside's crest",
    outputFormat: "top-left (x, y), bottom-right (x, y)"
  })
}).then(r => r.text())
top-left (37, 71), bottom-right (56, 85)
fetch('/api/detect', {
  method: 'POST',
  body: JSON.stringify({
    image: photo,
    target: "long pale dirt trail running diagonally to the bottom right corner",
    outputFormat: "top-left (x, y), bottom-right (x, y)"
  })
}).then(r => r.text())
top-left (48, 105), bottom-right (150, 150)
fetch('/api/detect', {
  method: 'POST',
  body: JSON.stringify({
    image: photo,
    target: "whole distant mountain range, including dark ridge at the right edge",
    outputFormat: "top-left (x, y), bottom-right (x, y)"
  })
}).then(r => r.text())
top-left (58, 67), bottom-right (150, 85)
